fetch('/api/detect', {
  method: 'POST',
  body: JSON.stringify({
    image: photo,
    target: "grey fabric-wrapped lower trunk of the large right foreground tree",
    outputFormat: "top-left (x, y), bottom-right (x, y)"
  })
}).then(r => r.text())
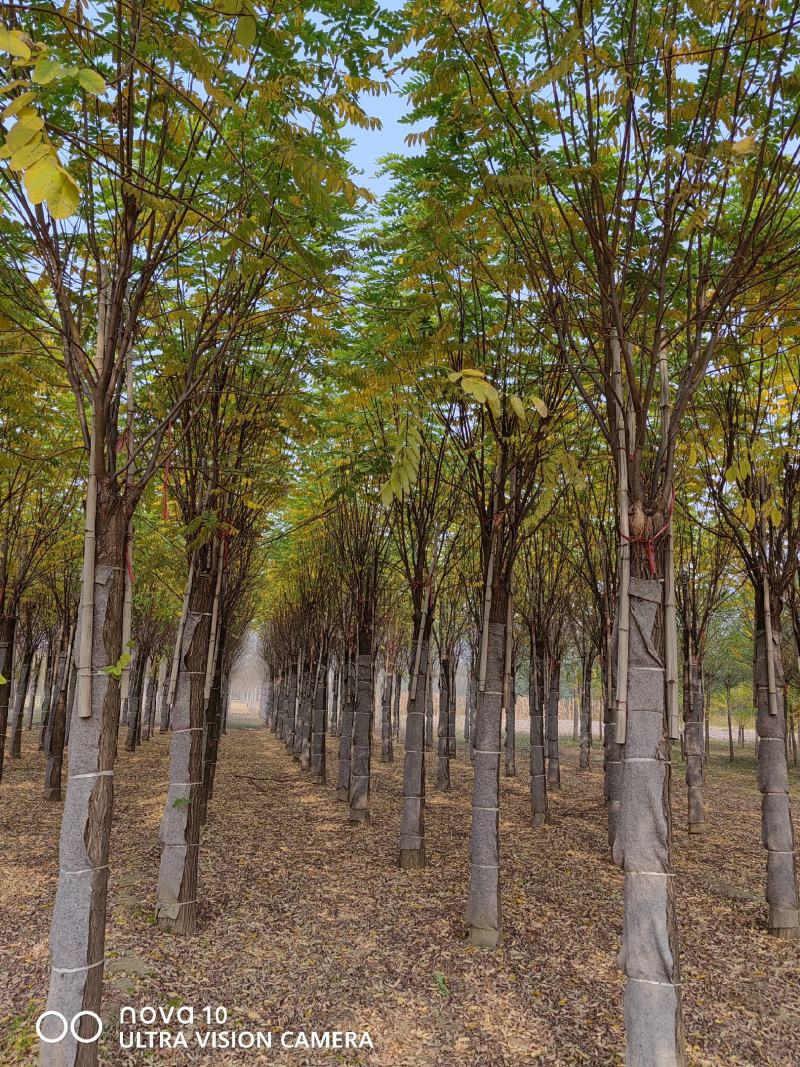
top-left (613, 580), bottom-right (686, 1067)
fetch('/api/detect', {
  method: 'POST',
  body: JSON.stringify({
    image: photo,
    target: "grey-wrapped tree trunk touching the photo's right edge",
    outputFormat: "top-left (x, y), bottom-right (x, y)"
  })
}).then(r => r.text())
top-left (755, 590), bottom-right (800, 938)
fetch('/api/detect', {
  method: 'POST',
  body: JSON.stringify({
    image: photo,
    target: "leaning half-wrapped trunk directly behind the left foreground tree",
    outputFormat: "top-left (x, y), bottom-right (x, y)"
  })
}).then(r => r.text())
top-left (156, 559), bottom-right (215, 934)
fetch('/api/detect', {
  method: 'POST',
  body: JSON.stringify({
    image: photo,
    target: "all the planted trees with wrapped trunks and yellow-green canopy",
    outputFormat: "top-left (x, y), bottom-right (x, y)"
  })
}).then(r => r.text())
top-left (0, 0), bottom-right (800, 1065)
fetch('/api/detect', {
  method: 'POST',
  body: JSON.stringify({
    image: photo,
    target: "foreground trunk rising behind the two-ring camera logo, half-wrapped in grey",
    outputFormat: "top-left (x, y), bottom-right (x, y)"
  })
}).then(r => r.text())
top-left (39, 486), bottom-right (127, 1067)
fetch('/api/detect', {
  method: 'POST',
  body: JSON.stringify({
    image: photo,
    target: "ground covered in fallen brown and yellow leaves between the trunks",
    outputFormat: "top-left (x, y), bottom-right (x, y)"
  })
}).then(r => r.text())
top-left (0, 729), bottom-right (800, 1067)
